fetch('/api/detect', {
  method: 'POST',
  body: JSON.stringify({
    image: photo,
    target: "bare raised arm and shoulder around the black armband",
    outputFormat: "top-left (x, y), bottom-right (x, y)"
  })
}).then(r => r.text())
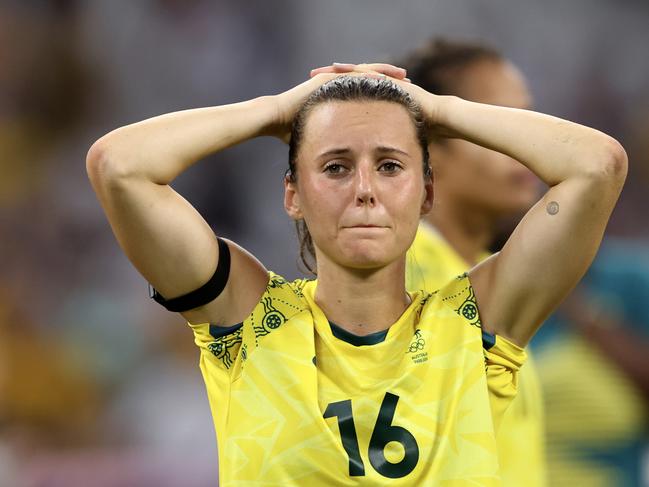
top-left (87, 75), bottom-right (335, 325)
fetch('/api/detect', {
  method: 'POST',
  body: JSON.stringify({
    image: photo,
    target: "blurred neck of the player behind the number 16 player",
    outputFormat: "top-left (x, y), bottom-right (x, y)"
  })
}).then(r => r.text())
top-left (426, 199), bottom-right (497, 267)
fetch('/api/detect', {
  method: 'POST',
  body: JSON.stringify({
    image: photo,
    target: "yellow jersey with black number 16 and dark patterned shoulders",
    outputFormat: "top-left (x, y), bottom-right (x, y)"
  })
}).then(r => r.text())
top-left (190, 272), bottom-right (525, 487)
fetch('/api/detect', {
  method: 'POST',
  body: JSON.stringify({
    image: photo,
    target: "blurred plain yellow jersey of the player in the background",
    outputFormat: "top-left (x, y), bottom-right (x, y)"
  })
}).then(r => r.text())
top-left (406, 223), bottom-right (546, 487)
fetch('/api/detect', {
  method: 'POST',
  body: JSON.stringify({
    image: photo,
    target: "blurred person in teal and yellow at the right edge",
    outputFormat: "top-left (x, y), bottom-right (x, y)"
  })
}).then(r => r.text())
top-left (533, 112), bottom-right (649, 487)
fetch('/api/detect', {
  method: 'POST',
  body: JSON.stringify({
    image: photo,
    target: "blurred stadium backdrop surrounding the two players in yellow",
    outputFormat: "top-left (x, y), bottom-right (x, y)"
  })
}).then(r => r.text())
top-left (0, 0), bottom-right (649, 487)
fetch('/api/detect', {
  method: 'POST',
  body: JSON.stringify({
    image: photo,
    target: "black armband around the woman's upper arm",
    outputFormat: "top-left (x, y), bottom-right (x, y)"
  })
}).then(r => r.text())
top-left (149, 237), bottom-right (230, 313)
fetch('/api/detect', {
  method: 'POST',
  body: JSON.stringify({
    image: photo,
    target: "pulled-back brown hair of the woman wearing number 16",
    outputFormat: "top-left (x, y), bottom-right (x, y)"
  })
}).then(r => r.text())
top-left (285, 76), bottom-right (431, 275)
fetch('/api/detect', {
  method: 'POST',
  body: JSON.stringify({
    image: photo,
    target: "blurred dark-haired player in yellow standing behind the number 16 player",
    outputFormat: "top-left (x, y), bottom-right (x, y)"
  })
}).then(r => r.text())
top-left (397, 39), bottom-right (545, 487)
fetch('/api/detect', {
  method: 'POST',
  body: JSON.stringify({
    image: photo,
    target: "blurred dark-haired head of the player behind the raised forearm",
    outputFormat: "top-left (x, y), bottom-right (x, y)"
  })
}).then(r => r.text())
top-left (401, 39), bottom-right (539, 216)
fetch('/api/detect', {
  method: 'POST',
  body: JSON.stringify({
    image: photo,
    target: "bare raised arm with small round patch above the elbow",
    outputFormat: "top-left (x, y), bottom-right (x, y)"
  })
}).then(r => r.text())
top-left (422, 94), bottom-right (627, 345)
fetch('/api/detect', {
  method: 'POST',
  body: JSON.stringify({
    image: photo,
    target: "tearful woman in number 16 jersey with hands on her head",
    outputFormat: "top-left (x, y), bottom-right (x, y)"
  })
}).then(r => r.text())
top-left (88, 65), bottom-right (626, 486)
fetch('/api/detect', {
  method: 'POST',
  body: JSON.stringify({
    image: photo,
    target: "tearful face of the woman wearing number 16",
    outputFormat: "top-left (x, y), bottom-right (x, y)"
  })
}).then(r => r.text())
top-left (285, 101), bottom-right (432, 269)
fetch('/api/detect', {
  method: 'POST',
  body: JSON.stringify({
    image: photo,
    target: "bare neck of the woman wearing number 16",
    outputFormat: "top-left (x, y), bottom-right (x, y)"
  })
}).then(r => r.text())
top-left (315, 257), bottom-right (410, 335)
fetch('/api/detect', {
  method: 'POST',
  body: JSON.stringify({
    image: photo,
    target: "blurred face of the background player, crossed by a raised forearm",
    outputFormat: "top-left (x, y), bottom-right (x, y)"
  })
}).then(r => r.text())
top-left (430, 60), bottom-right (540, 216)
